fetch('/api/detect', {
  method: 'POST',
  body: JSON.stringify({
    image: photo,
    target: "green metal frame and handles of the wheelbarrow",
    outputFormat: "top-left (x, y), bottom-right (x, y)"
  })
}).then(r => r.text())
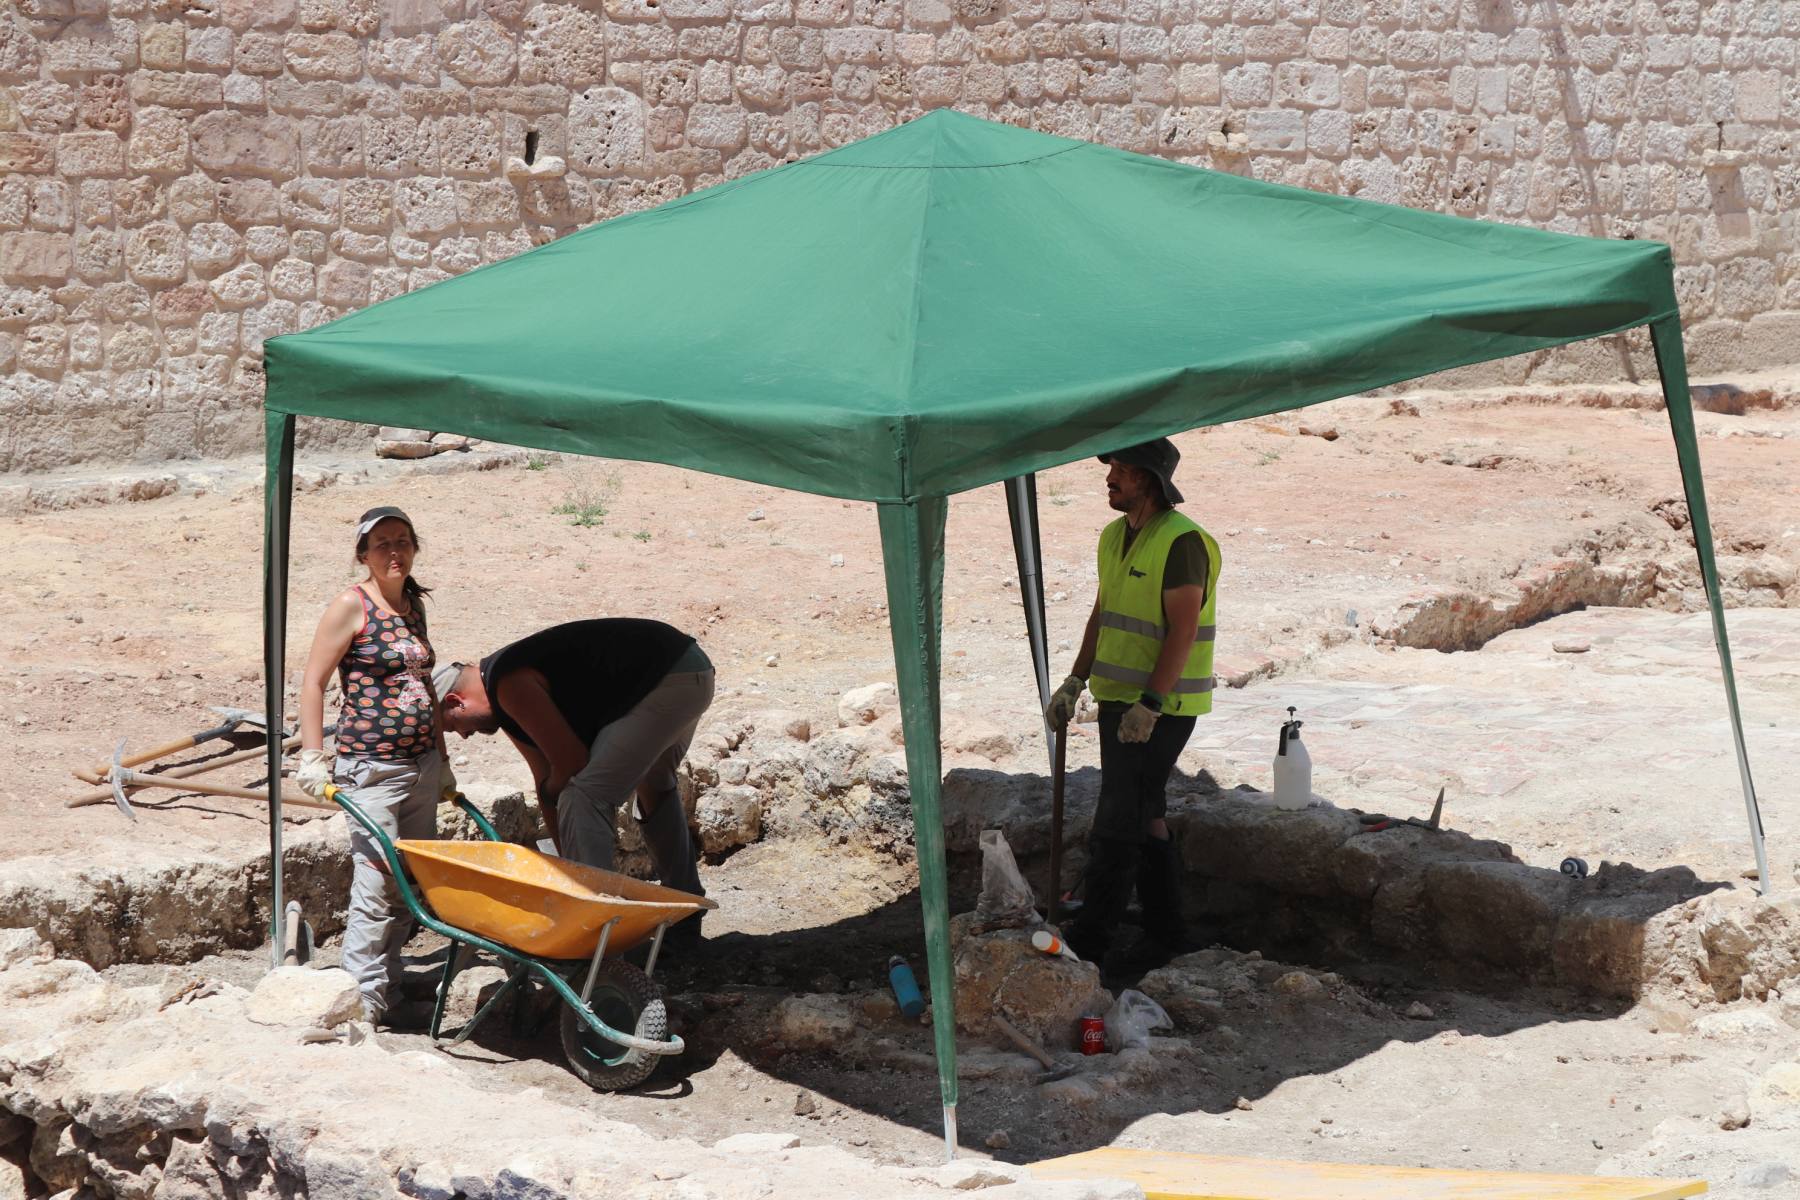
top-left (326, 786), bottom-right (686, 1054)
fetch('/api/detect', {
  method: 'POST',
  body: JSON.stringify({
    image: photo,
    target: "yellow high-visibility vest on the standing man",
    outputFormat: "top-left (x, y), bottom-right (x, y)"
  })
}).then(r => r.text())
top-left (1087, 509), bottom-right (1219, 716)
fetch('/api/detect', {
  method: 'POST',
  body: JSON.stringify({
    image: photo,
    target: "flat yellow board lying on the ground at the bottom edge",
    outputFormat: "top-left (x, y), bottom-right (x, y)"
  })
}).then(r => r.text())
top-left (1031, 1146), bottom-right (1706, 1200)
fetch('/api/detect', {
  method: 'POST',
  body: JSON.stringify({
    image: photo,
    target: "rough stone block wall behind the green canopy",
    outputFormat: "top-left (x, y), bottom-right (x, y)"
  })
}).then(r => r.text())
top-left (0, 0), bottom-right (1800, 471)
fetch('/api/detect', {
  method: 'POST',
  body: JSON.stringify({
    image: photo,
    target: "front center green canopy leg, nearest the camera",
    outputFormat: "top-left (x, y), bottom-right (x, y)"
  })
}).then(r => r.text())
top-left (877, 497), bottom-right (956, 1159)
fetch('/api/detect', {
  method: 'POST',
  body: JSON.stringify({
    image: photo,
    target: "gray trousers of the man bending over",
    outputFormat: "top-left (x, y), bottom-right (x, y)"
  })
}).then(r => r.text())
top-left (556, 657), bottom-right (713, 896)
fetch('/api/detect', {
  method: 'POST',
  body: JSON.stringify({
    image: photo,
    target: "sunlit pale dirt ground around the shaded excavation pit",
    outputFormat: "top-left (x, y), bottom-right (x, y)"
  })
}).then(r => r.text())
top-left (0, 372), bottom-right (1800, 1195)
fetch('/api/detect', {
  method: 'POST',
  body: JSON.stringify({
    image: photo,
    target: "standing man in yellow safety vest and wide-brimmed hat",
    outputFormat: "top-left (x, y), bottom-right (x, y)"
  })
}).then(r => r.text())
top-left (1046, 437), bottom-right (1219, 963)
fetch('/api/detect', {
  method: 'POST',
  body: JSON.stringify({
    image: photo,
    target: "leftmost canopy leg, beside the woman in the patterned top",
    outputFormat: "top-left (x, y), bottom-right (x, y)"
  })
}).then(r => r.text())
top-left (263, 410), bottom-right (293, 966)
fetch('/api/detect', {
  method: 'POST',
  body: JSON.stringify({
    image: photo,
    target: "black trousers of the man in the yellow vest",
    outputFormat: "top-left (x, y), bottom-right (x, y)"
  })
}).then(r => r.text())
top-left (1069, 703), bottom-right (1195, 963)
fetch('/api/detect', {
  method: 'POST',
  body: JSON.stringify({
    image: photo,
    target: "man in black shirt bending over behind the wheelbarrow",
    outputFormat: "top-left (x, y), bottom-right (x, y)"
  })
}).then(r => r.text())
top-left (434, 617), bottom-right (713, 939)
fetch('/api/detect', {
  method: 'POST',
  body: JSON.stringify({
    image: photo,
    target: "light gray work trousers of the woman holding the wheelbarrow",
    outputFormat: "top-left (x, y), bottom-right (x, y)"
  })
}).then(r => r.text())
top-left (333, 750), bottom-right (445, 1018)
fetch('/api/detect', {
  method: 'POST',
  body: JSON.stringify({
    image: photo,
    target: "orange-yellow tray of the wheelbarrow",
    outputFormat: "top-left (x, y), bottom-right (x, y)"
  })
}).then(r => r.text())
top-left (394, 840), bottom-right (718, 959)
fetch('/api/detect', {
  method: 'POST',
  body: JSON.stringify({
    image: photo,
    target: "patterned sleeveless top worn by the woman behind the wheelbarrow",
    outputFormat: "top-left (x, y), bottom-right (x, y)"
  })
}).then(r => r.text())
top-left (337, 588), bottom-right (437, 761)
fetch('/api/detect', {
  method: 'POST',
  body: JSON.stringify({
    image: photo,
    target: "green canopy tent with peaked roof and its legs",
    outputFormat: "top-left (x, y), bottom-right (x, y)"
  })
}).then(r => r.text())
top-left (265, 110), bottom-right (1768, 1151)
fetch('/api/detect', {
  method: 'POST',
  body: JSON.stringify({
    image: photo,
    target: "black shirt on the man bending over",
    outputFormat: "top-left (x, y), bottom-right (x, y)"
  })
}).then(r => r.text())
top-left (481, 617), bottom-right (693, 745)
